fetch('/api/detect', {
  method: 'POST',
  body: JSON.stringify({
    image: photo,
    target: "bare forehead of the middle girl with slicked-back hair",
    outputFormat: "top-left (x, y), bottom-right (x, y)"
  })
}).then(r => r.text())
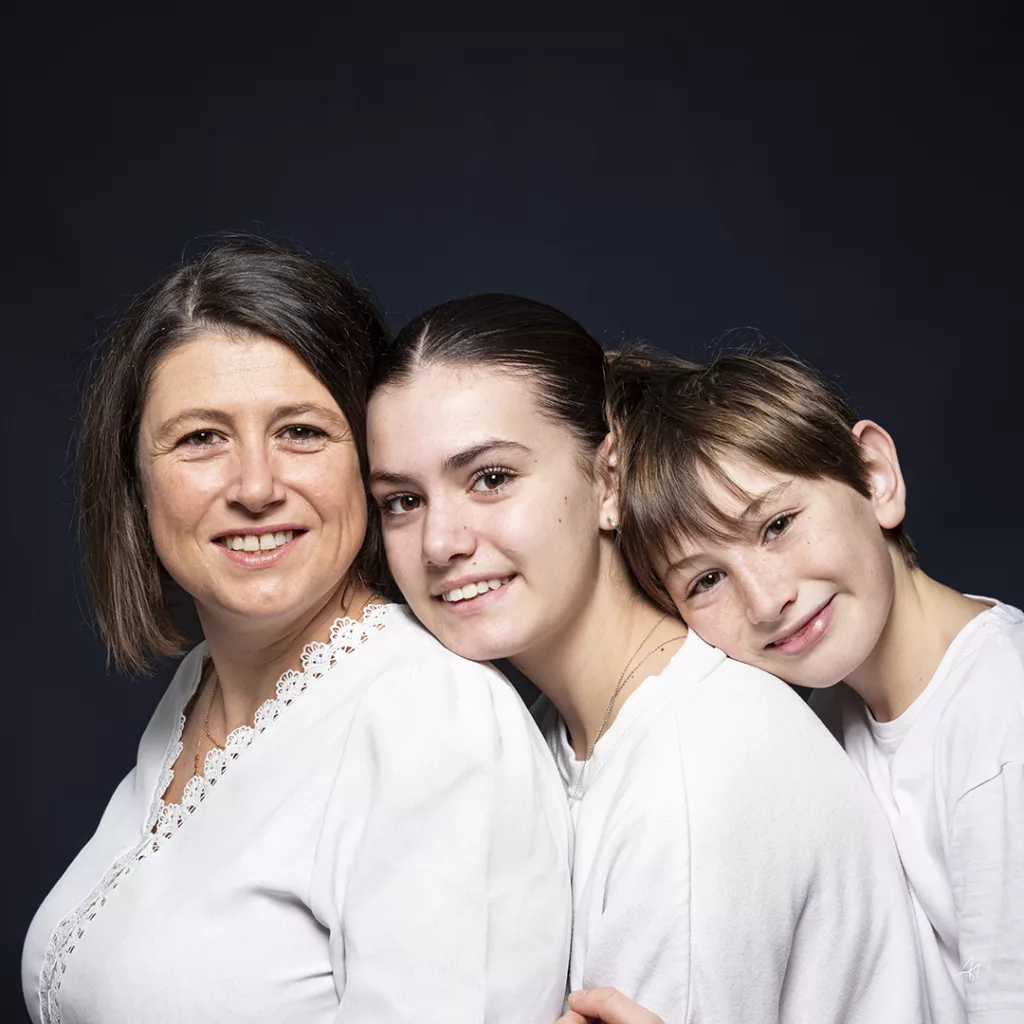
top-left (368, 365), bottom-right (573, 468)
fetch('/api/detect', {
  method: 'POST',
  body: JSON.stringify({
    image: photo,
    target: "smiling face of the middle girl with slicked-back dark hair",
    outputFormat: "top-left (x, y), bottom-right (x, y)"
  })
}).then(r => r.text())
top-left (369, 365), bottom-right (617, 660)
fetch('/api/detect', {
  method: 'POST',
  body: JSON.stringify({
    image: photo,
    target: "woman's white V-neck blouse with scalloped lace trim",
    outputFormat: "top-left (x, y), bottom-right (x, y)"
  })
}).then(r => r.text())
top-left (23, 605), bottom-right (570, 1024)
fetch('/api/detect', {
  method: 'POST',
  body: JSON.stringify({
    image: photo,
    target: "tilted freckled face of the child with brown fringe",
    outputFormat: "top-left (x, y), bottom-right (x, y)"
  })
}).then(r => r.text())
top-left (660, 460), bottom-right (902, 687)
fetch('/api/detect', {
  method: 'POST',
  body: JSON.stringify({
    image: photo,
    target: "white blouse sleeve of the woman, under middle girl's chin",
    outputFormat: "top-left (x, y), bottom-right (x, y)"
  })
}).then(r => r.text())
top-left (313, 657), bottom-right (570, 1024)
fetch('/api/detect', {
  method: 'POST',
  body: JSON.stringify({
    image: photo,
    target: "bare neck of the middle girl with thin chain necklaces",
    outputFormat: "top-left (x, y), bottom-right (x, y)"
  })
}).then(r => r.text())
top-left (510, 543), bottom-right (686, 759)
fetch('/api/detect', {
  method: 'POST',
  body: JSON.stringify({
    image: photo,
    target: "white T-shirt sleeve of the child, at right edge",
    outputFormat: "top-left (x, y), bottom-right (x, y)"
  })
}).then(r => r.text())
top-left (949, 761), bottom-right (1024, 1024)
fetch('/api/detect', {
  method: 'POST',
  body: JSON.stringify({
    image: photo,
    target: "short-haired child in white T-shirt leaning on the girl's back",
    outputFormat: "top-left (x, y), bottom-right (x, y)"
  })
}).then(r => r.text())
top-left (609, 350), bottom-right (1024, 1024)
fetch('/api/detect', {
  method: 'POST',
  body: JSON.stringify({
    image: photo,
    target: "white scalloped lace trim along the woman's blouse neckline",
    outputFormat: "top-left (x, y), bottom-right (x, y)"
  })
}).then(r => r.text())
top-left (39, 604), bottom-right (392, 1024)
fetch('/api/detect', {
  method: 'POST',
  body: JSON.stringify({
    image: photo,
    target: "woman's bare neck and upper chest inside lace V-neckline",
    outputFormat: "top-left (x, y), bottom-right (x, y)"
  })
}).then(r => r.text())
top-left (197, 582), bottom-right (372, 736)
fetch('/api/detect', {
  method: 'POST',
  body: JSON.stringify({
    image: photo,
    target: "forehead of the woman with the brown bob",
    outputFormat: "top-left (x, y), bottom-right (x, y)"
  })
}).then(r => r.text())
top-left (143, 331), bottom-right (337, 417)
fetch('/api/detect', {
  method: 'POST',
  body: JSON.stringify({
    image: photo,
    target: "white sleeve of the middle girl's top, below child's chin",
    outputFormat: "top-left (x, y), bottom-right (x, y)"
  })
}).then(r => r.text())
top-left (687, 679), bottom-right (929, 1024)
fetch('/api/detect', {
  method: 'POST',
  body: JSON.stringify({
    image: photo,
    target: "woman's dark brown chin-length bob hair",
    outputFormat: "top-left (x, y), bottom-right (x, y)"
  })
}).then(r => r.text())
top-left (78, 238), bottom-right (387, 674)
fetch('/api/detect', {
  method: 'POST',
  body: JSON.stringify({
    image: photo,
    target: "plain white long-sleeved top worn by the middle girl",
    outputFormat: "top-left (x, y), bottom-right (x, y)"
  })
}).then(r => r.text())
top-left (539, 631), bottom-right (944, 1024)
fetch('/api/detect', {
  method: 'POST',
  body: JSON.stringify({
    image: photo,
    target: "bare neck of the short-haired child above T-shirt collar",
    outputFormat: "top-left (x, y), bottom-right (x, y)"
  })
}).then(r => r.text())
top-left (846, 551), bottom-right (988, 722)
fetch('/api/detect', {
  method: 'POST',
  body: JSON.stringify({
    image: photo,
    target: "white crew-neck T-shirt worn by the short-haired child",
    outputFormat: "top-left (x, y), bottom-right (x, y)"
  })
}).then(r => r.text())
top-left (814, 598), bottom-right (1024, 1024)
